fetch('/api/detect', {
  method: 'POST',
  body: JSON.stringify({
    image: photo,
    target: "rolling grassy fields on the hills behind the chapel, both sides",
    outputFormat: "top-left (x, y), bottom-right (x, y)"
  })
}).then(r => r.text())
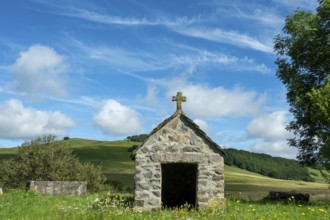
top-left (0, 138), bottom-right (330, 201)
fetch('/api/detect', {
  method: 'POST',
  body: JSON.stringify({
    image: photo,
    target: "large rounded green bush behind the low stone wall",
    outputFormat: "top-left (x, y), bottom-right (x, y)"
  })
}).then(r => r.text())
top-left (0, 135), bottom-right (105, 191)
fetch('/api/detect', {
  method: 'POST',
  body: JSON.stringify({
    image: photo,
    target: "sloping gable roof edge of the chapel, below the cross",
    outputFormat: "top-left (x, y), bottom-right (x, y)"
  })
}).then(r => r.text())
top-left (131, 110), bottom-right (227, 160)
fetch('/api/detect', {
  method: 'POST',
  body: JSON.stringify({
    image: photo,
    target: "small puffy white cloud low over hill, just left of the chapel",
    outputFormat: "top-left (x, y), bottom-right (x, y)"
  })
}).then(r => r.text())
top-left (94, 100), bottom-right (143, 136)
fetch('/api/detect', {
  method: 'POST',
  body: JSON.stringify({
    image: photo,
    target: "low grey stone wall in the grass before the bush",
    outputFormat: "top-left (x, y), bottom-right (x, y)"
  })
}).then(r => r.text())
top-left (29, 181), bottom-right (87, 196)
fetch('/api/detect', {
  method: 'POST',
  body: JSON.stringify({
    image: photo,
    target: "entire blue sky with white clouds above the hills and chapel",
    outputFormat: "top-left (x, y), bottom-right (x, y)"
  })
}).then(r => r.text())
top-left (0, 0), bottom-right (317, 158)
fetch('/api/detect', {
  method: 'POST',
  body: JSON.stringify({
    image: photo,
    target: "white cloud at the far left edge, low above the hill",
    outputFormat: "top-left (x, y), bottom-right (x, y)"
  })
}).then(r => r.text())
top-left (0, 99), bottom-right (75, 139)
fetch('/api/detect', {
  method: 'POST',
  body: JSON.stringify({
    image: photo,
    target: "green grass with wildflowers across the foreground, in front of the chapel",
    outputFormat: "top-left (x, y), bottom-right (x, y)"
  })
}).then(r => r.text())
top-left (0, 191), bottom-right (330, 220)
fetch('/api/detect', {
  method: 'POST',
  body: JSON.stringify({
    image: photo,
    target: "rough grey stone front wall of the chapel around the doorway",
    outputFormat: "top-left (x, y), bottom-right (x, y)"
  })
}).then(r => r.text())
top-left (134, 116), bottom-right (224, 209)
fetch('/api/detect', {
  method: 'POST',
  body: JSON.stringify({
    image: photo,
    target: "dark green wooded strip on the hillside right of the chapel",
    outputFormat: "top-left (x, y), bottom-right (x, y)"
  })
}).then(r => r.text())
top-left (224, 148), bottom-right (314, 182)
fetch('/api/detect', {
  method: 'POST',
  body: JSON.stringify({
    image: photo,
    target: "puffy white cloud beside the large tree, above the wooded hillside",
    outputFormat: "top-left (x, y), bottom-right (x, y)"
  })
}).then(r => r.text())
top-left (247, 111), bottom-right (291, 141)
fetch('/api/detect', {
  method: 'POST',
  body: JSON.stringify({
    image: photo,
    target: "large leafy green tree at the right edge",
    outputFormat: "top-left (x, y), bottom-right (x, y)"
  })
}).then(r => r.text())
top-left (275, 0), bottom-right (330, 172)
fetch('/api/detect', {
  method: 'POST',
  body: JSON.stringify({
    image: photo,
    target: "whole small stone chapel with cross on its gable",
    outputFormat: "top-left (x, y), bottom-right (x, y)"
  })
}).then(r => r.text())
top-left (132, 92), bottom-right (225, 210)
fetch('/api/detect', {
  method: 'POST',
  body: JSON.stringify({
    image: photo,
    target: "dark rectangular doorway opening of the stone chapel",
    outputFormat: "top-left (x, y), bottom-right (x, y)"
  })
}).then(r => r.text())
top-left (162, 163), bottom-right (197, 208)
